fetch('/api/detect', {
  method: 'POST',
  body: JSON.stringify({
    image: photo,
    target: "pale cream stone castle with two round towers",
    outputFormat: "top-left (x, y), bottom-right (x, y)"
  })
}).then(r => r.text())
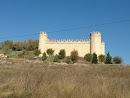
top-left (38, 32), bottom-right (105, 57)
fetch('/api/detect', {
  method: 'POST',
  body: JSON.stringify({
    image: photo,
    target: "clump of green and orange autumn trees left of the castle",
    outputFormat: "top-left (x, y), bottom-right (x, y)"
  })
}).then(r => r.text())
top-left (0, 39), bottom-right (39, 51)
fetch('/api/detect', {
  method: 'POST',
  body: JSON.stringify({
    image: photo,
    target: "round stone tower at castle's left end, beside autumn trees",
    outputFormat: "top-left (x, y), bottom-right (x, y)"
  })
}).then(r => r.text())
top-left (38, 32), bottom-right (48, 56)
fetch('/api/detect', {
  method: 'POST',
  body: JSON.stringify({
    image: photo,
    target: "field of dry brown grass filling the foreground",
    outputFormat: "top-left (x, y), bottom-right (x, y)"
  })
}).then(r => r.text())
top-left (0, 63), bottom-right (130, 98)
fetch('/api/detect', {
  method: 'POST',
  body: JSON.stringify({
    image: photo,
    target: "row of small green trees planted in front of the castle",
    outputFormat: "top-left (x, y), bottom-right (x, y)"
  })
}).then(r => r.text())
top-left (42, 48), bottom-right (122, 64)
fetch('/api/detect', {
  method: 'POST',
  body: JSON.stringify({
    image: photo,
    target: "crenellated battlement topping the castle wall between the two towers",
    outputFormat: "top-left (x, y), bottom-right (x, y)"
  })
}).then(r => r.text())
top-left (47, 39), bottom-right (90, 44)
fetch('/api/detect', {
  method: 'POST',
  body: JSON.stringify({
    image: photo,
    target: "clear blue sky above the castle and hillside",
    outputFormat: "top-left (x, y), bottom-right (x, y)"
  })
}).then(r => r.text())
top-left (0, 0), bottom-right (130, 64)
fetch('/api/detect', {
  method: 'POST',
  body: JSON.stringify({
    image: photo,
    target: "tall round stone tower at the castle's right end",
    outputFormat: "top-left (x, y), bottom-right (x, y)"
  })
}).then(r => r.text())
top-left (90, 32), bottom-right (102, 56)
